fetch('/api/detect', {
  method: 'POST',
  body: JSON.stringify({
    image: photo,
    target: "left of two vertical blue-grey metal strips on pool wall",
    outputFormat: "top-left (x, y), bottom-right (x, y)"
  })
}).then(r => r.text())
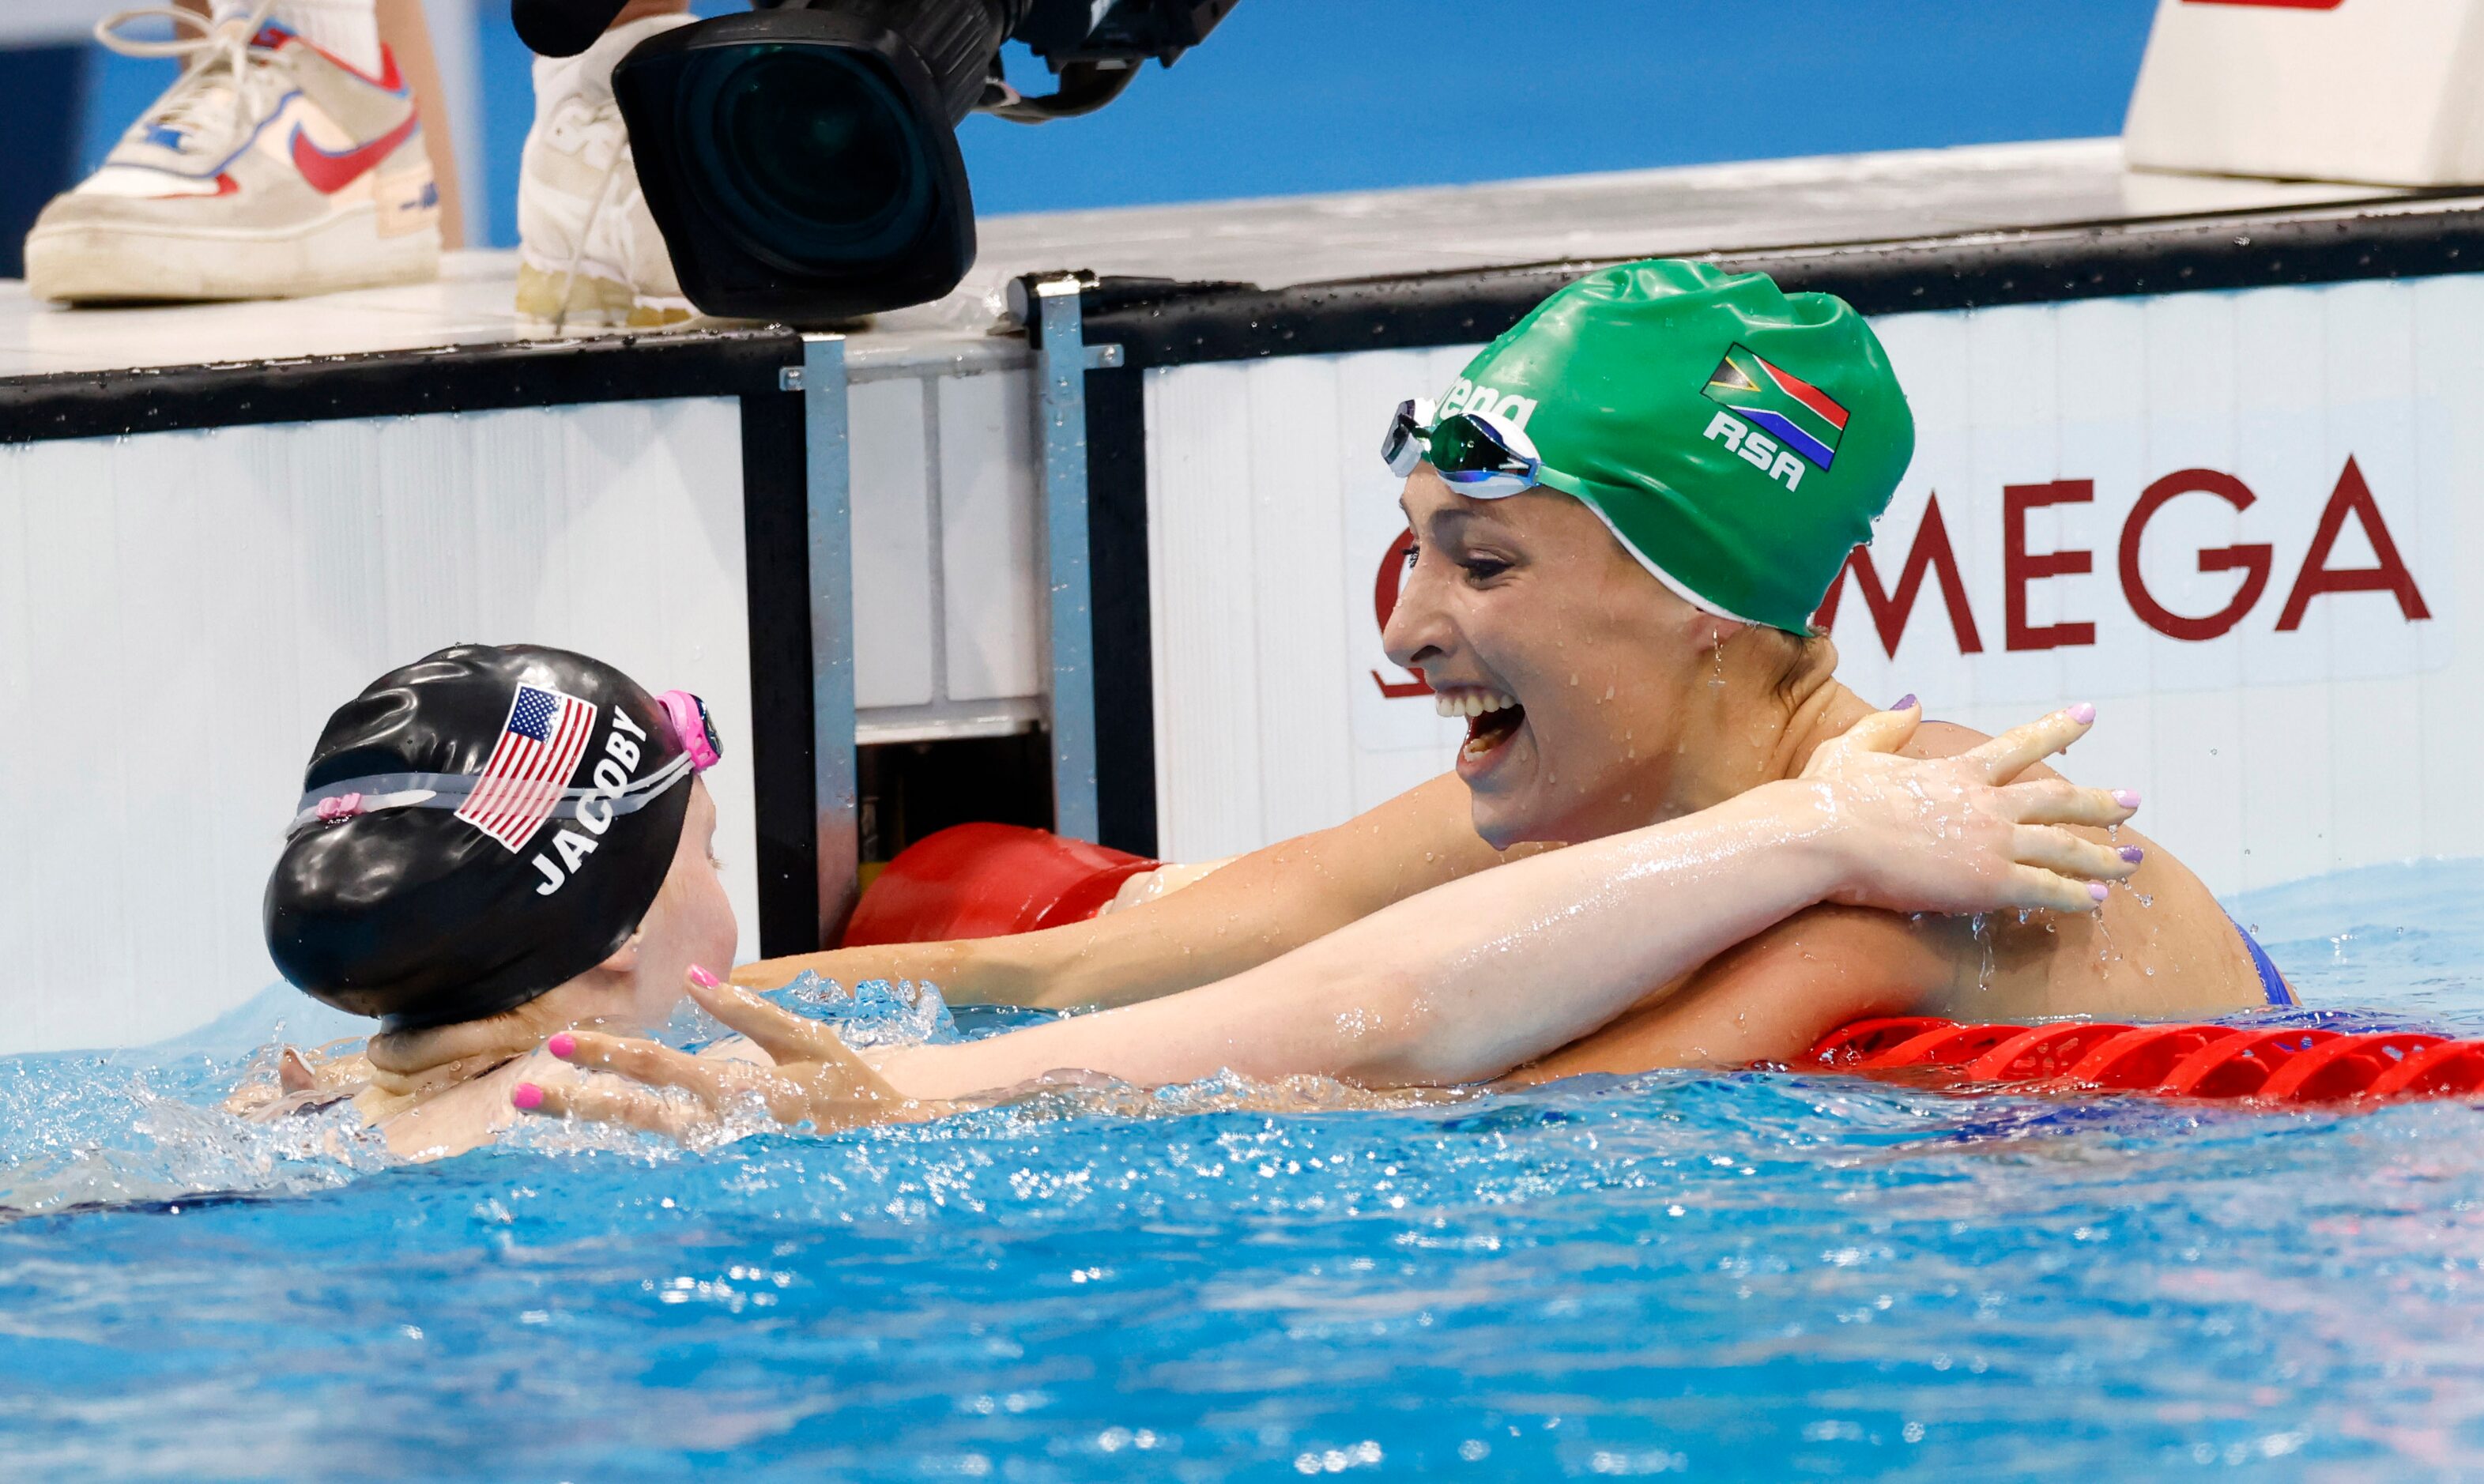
top-left (809, 335), bottom-right (862, 948)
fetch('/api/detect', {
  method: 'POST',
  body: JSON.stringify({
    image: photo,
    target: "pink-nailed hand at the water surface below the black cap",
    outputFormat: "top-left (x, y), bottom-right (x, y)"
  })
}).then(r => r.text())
top-left (511, 968), bottom-right (918, 1139)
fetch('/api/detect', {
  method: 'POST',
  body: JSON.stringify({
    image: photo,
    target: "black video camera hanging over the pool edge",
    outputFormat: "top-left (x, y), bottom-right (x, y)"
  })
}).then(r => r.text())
top-left (511, 0), bottom-right (1237, 325)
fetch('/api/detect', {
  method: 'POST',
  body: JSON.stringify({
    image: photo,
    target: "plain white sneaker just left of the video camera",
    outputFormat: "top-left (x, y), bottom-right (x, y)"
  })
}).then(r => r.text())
top-left (517, 15), bottom-right (698, 330)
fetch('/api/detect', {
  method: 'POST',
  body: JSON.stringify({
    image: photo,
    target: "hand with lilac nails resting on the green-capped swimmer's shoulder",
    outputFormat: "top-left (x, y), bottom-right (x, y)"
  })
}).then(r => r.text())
top-left (1771, 702), bottom-right (2139, 913)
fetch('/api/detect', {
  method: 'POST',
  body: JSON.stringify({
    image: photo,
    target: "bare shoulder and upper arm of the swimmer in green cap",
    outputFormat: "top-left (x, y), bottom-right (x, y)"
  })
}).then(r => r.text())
top-left (1521, 722), bottom-right (2263, 1082)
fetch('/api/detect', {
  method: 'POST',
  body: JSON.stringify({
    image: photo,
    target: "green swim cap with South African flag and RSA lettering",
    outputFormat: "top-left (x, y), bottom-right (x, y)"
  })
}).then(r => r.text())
top-left (1441, 258), bottom-right (1915, 633)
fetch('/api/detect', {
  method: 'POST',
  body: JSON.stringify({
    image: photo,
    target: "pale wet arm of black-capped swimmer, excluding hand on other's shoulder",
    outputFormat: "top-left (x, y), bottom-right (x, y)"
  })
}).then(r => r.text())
top-left (880, 784), bottom-right (1843, 1097)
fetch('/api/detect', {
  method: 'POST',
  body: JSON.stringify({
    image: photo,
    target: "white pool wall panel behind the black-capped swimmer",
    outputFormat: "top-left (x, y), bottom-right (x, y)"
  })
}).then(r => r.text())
top-left (0, 400), bottom-right (758, 1053)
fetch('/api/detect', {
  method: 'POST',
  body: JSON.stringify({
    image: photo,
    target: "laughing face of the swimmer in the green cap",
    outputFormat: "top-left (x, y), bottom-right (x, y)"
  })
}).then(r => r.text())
top-left (1381, 464), bottom-right (1717, 849)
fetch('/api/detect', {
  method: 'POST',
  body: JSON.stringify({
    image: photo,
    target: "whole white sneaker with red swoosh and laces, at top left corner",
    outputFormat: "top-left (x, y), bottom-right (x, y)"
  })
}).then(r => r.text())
top-left (25, 0), bottom-right (439, 303)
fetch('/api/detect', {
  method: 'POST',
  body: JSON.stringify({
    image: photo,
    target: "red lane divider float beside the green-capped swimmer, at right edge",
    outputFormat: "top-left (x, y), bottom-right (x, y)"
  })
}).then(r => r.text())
top-left (1801, 1015), bottom-right (2484, 1105)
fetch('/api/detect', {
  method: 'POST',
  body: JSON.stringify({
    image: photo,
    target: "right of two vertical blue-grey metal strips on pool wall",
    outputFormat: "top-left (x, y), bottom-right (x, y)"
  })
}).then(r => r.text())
top-left (1033, 276), bottom-right (1120, 838)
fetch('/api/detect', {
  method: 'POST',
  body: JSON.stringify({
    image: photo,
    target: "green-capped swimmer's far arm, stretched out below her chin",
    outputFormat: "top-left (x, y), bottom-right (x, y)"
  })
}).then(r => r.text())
top-left (733, 774), bottom-right (1538, 1010)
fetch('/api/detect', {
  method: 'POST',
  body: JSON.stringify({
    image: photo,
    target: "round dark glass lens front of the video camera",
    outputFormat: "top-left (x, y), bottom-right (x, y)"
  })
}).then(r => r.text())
top-left (680, 45), bottom-right (937, 266)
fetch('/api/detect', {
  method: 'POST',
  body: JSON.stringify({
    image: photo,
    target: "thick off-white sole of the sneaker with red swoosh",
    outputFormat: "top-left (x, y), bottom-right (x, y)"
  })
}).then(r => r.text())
top-left (25, 206), bottom-right (439, 303)
